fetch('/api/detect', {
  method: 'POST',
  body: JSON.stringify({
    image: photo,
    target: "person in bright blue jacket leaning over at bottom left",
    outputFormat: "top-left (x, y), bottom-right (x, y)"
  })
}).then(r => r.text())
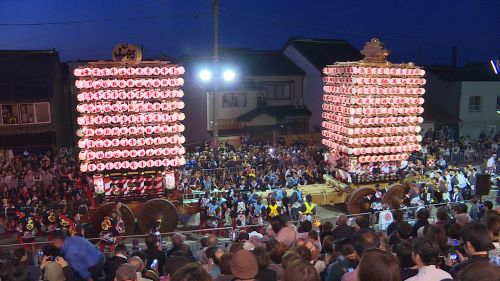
top-left (54, 232), bottom-right (103, 281)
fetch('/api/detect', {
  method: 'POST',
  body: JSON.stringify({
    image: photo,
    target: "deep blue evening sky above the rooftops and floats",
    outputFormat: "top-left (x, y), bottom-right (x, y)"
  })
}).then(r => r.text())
top-left (0, 0), bottom-right (500, 64)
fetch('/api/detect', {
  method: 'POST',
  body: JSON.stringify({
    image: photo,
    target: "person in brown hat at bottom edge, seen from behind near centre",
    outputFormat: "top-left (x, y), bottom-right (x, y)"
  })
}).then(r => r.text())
top-left (229, 249), bottom-right (259, 281)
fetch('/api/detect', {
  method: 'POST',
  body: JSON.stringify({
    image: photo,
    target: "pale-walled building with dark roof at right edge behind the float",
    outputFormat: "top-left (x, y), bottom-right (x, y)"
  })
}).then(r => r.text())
top-left (424, 63), bottom-right (500, 138)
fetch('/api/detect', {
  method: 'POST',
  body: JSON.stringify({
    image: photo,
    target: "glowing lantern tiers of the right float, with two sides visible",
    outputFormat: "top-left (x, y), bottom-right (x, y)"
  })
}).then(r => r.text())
top-left (322, 57), bottom-right (426, 179)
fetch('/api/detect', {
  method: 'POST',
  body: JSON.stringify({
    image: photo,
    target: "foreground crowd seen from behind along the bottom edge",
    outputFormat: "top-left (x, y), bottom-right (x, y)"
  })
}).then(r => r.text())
top-left (0, 204), bottom-right (500, 281)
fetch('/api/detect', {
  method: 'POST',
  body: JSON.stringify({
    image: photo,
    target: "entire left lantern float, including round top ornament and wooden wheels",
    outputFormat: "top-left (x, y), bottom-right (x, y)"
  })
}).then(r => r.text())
top-left (74, 44), bottom-right (185, 234)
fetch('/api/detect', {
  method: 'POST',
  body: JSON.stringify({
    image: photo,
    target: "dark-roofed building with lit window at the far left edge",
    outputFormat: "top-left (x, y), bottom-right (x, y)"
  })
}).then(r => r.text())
top-left (0, 50), bottom-right (71, 150)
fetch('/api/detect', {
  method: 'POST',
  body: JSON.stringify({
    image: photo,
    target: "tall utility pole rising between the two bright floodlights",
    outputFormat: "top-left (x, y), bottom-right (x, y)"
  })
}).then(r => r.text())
top-left (212, 0), bottom-right (220, 148)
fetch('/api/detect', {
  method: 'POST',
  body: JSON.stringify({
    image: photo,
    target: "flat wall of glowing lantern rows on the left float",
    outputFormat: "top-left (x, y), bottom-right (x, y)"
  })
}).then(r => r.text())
top-left (73, 62), bottom-right (185, 173)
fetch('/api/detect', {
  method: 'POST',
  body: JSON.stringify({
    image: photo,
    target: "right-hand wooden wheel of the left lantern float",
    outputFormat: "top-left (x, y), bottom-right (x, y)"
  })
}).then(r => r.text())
top-left (137, 198), bottom-right (179, 234)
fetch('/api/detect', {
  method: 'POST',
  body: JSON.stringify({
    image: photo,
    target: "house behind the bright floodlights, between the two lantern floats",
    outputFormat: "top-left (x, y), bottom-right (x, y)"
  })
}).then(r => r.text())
top-left (181, 49), bottom-right (311, 143)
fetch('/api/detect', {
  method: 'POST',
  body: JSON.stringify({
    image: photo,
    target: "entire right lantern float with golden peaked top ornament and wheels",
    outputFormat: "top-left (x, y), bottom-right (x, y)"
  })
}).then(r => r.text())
top-left (322, 39), bottom-right (426, 213)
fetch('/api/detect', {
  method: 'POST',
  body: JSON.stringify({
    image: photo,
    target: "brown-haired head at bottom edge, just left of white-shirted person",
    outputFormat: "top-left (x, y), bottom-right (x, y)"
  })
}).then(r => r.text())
top-left (357, 249), bottom-right (401, 281)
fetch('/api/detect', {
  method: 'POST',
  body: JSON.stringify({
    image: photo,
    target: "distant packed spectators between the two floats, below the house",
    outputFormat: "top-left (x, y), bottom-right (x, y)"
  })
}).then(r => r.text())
top-left (183, 138), bottom-right (326, 189)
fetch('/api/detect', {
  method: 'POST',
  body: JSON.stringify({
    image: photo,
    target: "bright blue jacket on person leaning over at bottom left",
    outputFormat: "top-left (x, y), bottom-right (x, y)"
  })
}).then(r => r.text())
top-left (61, 236), bottom-right (102, 280)
